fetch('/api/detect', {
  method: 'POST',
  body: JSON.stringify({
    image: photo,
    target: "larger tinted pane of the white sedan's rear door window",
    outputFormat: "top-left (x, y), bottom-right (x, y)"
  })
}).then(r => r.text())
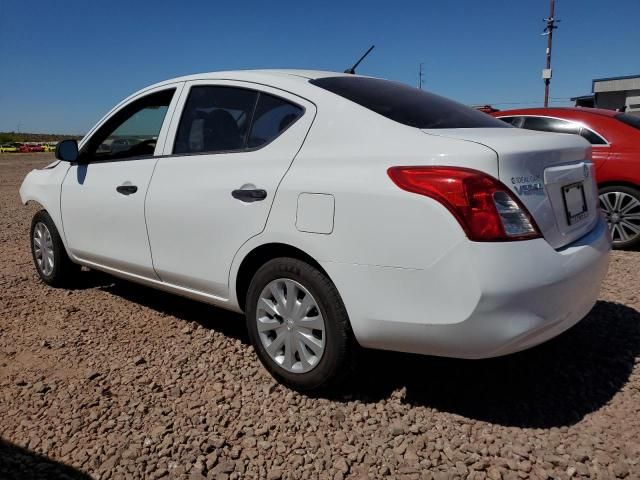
top-left (173, 86), bottom-right (258, 154)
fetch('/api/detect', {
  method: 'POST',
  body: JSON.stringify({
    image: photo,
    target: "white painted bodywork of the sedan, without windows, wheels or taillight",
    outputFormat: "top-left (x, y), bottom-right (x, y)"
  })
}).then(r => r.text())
top-left (21, 71), bottom-right (610, 358)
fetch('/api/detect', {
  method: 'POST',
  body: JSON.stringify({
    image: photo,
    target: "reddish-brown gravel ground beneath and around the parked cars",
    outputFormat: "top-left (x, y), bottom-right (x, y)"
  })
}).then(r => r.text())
top-left (0, 155), bottom-right (640, 479)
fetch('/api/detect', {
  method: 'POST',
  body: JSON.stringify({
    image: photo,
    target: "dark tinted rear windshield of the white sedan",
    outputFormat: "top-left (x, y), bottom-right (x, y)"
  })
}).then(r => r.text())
top-left (310, 76), bottom-right (512, 128)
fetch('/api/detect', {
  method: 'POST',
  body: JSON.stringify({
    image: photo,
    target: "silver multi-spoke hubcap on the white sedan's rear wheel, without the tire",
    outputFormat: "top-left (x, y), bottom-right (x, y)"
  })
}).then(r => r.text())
top-left (256, 278), bottom-right (325, 373)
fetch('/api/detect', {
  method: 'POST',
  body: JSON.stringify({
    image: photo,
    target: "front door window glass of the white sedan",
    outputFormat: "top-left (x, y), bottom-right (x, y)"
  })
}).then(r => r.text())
top-left (80, 89), bottom-right (175, 161)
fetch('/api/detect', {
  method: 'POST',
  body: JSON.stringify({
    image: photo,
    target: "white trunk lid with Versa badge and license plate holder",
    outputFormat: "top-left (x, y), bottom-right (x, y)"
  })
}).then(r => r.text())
top-left (424, 128), bottom-right (600, 249)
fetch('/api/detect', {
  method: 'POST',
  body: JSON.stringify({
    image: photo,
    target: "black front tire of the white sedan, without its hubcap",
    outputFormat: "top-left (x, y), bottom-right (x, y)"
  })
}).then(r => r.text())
top-left (29, 210), bottom-right (81, 288)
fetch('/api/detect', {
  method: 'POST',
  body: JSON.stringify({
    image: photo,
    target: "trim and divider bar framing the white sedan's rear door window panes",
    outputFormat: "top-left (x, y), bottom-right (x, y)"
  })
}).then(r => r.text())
top-left (170, 81), bottom-right (307, 158)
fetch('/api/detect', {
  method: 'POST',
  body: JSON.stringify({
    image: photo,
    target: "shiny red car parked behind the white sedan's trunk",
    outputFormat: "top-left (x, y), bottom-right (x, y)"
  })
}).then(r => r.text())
top-left (491, 108), bottom-right (640, 248)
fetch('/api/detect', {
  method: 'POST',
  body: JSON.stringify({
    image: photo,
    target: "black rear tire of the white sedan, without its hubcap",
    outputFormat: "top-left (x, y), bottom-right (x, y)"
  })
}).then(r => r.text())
top-left (246, 258), bottom-right (359, 391)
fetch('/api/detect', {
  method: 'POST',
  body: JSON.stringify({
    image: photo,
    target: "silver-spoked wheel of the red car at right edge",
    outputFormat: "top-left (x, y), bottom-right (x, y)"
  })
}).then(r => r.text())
top-left (600, 185), bottom-right (640, 249)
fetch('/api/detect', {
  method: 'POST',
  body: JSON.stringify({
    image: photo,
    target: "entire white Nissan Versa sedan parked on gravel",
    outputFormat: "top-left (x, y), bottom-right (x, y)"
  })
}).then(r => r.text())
top-left (20, 70), bottom-right (610, 390)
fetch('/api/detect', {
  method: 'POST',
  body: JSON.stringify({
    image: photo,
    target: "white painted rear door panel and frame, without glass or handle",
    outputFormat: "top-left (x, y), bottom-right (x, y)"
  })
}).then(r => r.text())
top-left (146, 81), bottom-right (315, 298)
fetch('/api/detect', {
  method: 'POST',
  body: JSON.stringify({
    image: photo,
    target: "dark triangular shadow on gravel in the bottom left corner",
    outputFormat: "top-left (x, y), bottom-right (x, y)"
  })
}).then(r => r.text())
top-left (0, 438), bottom-right (91, 480)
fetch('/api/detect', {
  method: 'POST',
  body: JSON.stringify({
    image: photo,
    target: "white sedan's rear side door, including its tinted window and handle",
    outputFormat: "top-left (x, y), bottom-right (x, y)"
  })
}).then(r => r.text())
top-left (146, 81), bottom-right (315, 299)
